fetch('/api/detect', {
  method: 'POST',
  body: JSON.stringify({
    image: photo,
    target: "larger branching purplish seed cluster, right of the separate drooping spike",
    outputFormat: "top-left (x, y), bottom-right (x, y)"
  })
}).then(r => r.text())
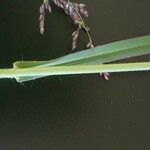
top-left (52, 0), bottom-right (94, 50)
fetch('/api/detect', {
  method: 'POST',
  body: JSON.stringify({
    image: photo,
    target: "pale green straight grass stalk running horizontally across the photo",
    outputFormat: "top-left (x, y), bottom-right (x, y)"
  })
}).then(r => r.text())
top-left (0, 62), bottom-right (150, 81)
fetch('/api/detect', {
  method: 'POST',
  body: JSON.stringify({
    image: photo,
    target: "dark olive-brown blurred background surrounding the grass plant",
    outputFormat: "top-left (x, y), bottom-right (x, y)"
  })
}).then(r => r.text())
top-left (0, 0), bottom-right (150, 150)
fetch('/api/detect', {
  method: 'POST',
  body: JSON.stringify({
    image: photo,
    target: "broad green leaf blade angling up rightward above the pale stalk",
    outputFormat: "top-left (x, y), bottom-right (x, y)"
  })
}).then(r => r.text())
top-left (14, 35), bottom-right (150, 68)
